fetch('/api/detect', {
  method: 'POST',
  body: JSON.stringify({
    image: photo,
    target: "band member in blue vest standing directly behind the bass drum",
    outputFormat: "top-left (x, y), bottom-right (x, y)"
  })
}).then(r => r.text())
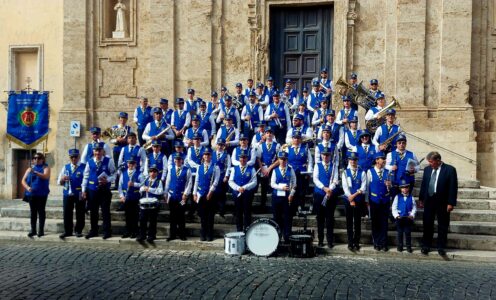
top-left (270, 151), bottom-right (296, 244)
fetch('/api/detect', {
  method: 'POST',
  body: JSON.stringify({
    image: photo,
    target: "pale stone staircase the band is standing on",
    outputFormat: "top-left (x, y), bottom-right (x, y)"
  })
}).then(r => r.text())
top-left (0, 179), bottom-right (496, 250)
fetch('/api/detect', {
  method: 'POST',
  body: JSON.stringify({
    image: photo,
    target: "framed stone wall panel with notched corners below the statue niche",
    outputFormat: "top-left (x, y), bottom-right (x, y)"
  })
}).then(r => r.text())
top-left (98, 57), bottom-right (137, 98)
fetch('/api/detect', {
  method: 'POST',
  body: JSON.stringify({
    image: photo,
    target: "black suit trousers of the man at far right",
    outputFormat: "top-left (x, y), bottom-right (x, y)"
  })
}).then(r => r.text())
top-left (422, 195), bottom-right (450, 249)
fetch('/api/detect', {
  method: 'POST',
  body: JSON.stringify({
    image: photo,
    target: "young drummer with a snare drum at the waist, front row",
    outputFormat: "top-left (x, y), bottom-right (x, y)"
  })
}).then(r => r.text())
top-left (136, 165), bottom-right (164, 243)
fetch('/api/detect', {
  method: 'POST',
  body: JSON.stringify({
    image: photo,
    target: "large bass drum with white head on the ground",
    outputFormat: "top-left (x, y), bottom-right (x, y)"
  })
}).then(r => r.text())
top-left (246, 218), bottom-right (281, 256)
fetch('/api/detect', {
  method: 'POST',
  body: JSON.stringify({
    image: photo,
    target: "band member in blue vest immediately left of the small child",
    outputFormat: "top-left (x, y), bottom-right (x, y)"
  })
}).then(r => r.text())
top-left (367, 151), bottom-right (391, 252)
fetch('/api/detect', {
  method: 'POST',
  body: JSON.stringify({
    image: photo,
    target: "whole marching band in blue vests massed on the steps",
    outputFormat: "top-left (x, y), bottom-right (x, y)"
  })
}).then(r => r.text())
top-left (26, 68), bottom-right (426, 252)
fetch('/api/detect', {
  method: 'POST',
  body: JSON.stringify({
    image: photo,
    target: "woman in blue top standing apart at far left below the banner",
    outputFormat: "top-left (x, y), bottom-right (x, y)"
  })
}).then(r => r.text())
top-left (22, 153), bottom-right (50, 237)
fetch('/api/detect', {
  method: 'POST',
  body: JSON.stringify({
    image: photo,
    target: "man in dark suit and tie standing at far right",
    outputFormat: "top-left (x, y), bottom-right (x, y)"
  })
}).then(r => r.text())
top-left (419, 152), bottom-right (458, 256)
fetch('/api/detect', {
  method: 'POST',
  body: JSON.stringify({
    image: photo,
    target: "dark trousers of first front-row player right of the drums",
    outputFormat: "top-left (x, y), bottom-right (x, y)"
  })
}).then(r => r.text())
top-left (313, 193), bottom-right (337, 244)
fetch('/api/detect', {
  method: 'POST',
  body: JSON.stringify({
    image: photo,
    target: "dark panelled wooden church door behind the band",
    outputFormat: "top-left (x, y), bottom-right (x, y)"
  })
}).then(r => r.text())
top-left (270, 6), bottom-right (333, 91)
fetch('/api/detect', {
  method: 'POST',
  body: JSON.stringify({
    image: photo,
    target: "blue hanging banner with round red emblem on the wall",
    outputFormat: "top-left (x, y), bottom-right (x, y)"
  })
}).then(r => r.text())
top-left (7, 91), bottom-right (49, 149)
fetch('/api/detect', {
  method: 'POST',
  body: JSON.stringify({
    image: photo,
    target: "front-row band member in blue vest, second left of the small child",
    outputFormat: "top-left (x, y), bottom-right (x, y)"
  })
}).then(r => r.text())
top-left (341, 152), bottom-right (367, 251)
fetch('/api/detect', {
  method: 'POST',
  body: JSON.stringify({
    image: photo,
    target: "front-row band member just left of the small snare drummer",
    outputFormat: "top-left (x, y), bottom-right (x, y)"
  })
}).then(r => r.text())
top-left (119, 156), bottom-right (143, 239)
